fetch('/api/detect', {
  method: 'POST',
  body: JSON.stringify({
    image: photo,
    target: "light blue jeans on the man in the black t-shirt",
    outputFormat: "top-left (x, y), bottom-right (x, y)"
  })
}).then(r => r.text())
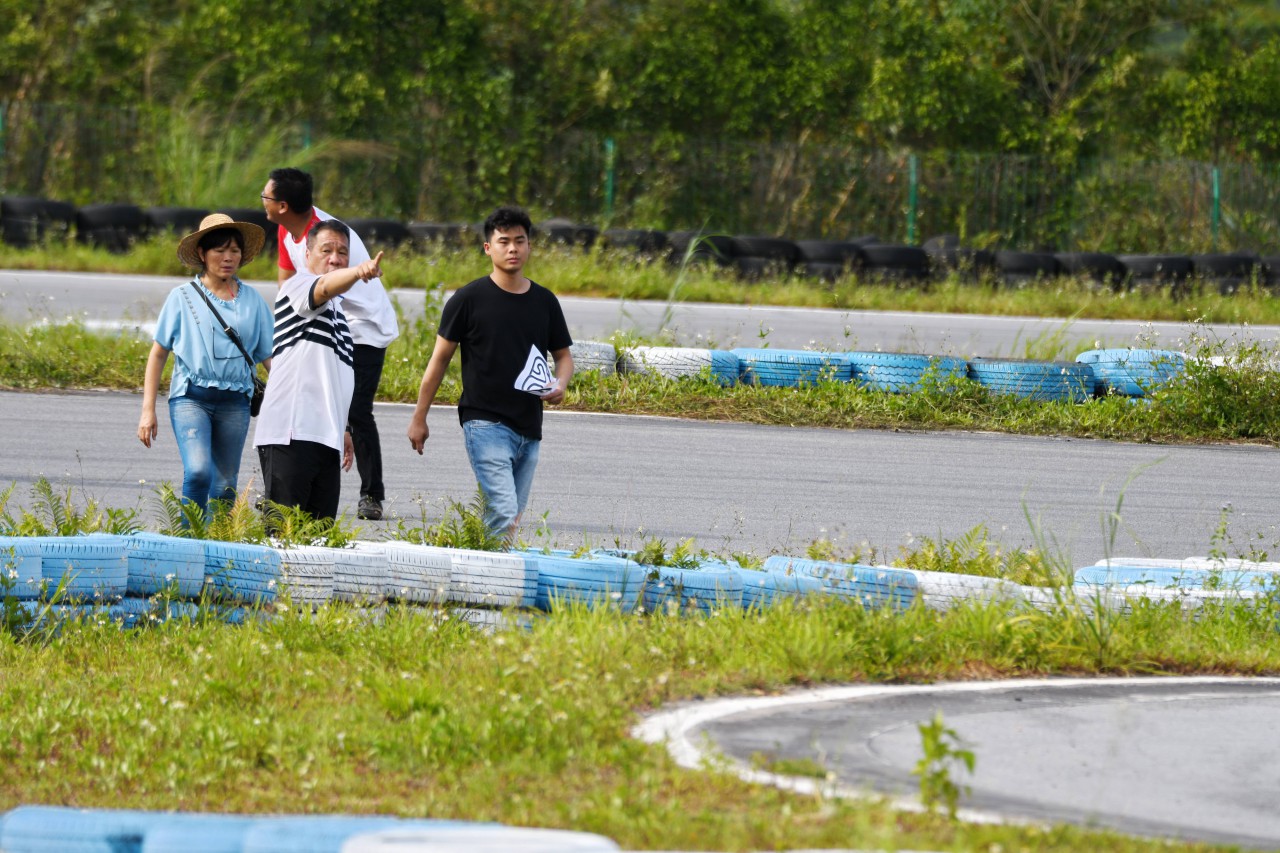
top-left (462, 420), bottom-right (541, 535)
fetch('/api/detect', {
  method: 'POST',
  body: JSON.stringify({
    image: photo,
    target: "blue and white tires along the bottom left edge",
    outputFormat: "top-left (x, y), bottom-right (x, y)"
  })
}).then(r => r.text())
top-left (0, 806), bottom-right (620, 853)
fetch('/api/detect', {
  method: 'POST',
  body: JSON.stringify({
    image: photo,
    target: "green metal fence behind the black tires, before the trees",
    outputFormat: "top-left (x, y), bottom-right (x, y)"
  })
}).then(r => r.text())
top-left (0, 104), bottom-right (1280, 254)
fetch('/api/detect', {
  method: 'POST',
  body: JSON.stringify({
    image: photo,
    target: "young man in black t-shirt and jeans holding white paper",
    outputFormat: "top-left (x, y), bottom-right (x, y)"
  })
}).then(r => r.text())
top-left (408, 207), bottom-right (573, 537)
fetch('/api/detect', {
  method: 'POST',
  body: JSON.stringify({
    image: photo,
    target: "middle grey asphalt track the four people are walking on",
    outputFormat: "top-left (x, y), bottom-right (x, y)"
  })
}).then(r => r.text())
top-left (0, 392), bottom-right (1280, 566)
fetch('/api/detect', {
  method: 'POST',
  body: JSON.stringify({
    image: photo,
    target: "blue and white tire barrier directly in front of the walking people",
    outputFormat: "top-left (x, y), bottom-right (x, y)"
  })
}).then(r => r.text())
top-left (0, 533), bottom-right (1249, 628)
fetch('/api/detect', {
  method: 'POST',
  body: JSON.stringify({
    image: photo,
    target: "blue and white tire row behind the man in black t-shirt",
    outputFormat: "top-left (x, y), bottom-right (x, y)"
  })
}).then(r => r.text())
top-left (571, 341), bottom-right (1187, 402)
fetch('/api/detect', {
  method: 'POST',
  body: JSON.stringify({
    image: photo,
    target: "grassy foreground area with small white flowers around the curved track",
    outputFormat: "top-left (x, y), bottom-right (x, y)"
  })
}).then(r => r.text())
top-left (0, 573), bottom-right (1280, 850)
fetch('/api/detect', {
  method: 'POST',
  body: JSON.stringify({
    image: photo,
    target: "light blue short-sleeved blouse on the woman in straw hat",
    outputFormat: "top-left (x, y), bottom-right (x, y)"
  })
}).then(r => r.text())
top-left (155, 278), bottom-right (274, 397)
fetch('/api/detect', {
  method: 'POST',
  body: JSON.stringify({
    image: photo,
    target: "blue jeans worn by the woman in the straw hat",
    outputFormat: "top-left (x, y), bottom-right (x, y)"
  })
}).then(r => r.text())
top-left (169, 383), bottom-right (248, 510)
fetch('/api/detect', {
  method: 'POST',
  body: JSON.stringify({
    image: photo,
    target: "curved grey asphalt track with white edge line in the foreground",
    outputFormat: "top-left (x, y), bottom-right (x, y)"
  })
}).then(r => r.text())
top-left (640, 679), bottom-right (1280, 849)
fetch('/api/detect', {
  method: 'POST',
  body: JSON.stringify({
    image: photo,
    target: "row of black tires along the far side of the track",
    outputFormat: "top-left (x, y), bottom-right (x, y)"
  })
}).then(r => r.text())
top-left (0, 196), bottom-right (1280, 292)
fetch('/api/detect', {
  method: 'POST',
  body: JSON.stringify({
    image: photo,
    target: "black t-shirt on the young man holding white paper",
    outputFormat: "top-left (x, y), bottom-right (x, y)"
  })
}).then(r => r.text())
top-left (440, 275), bottom-right (573, 439)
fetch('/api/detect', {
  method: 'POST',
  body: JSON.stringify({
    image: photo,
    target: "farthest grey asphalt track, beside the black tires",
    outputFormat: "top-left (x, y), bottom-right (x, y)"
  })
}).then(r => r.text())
top-left (0, 270), bottom-right (1280, 357)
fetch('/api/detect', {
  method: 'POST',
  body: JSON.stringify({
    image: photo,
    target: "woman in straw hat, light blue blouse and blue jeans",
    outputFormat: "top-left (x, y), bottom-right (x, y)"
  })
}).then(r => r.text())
top-left (138, 213), bottom-right (273, 511)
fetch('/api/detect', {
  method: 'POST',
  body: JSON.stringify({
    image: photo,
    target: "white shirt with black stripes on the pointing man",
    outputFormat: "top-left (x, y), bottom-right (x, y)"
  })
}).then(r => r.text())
top-left (253, 272), bottom-right (356, 453)
